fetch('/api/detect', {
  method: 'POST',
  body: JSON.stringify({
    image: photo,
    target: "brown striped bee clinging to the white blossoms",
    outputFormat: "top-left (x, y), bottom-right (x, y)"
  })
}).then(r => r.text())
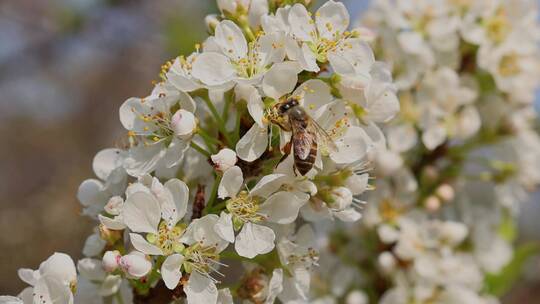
top-left (270, 96), bottom-right (337, 176)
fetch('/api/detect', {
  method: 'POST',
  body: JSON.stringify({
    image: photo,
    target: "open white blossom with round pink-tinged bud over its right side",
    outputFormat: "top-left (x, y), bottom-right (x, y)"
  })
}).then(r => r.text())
top-left (120, 84), bottom-right (196, 177)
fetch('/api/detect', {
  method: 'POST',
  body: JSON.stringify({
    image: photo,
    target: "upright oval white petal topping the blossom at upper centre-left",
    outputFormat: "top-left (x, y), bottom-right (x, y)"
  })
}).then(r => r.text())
top-left (215, 20), bottom-right (248, 60)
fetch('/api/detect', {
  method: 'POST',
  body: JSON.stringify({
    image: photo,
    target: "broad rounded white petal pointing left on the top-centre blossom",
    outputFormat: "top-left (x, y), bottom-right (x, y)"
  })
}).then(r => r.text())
top-left (192, 52), bottom-right (236, 86)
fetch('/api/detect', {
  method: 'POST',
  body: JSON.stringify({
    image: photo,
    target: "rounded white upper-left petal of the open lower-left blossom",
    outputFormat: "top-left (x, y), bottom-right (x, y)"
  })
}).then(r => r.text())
top-left (122, 192), bottom-right (161, 234)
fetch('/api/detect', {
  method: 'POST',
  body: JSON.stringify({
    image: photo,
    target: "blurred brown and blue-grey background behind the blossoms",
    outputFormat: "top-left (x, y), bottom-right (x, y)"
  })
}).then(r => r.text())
top-left (0, 0), bottom-right (540, 303)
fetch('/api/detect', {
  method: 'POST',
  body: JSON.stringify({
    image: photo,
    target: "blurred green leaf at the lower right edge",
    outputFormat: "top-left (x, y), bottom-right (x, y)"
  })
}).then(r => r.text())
top-left (484, 243), bottom-right (540, 296)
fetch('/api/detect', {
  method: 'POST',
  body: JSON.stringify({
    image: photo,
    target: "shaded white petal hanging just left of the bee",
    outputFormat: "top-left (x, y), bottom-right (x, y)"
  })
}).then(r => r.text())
top-left (236, 124), bottom-right (268, 162)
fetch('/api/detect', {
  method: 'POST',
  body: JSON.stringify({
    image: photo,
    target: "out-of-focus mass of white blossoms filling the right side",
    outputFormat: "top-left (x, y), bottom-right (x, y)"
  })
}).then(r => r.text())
top-left (322, 0), bottom-right (540, 304)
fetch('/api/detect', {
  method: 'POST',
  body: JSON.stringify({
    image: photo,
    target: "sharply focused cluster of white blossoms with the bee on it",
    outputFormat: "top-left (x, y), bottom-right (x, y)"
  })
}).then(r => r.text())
top-left (0, 0), bottom-right (399, 304)
